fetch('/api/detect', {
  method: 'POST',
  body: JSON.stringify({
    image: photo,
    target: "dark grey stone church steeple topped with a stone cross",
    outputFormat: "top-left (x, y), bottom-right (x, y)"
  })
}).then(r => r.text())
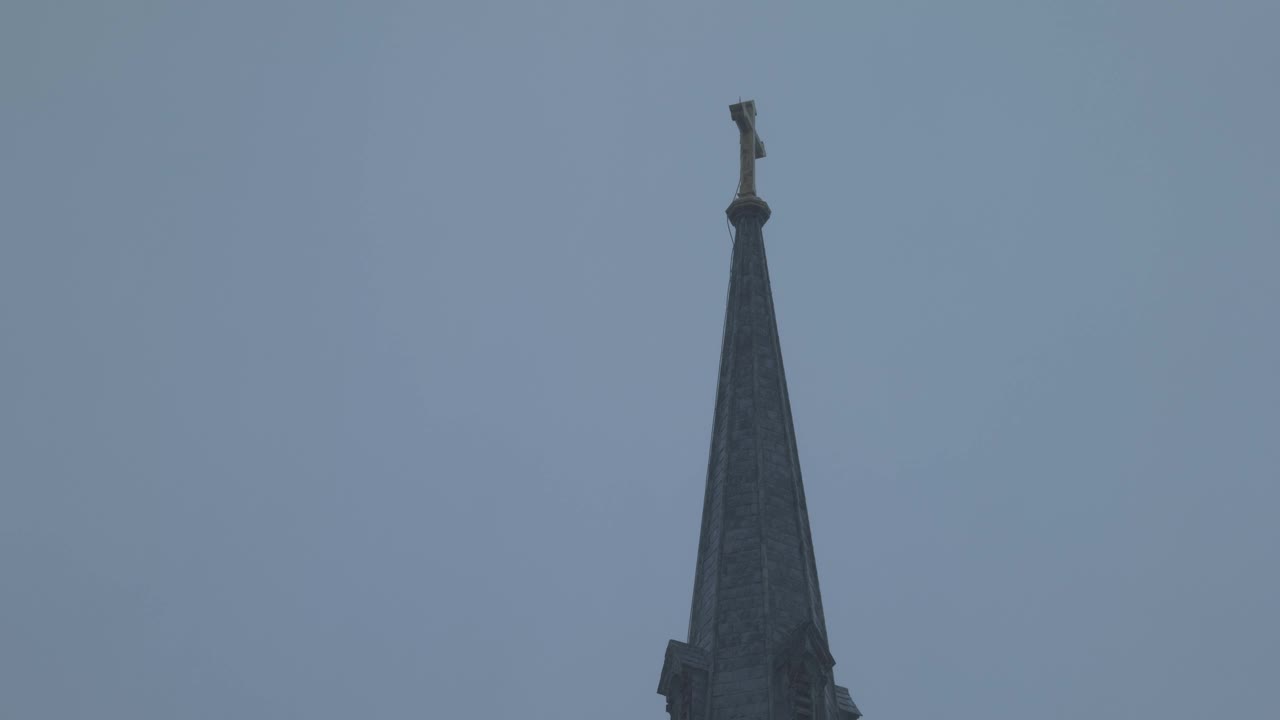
top-left (658, 100), bottom-right (860, 720)
